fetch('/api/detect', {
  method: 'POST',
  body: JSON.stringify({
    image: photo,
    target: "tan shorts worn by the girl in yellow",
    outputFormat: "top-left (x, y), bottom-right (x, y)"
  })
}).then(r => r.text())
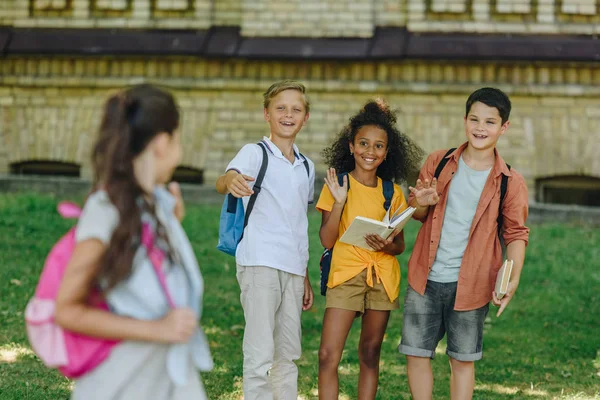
top-left (325, 268), bottom-right (400, 313)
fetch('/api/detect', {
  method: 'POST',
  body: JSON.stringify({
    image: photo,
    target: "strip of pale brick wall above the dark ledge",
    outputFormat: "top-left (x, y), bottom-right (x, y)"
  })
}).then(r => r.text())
top-left (0, 0), bottom-right (600, 37)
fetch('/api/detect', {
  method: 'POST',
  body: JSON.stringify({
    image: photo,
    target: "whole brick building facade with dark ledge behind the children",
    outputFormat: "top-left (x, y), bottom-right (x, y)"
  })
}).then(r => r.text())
top-left (0, 0), bottom-right (600, 205)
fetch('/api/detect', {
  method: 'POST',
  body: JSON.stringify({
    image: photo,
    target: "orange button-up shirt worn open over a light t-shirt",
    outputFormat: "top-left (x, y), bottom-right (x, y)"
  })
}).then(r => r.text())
top-left (408, 143), bottom-right (529, 311)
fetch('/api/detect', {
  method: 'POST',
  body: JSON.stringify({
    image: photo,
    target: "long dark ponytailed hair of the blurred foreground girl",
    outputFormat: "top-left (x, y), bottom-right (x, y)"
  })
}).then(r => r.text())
top-left (92, 85), bottom-right (179, 289)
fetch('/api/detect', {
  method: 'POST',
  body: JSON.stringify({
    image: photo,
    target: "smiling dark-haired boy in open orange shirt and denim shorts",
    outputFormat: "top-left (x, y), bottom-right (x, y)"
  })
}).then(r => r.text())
top-left (399, 88), bottom-right (529, 400)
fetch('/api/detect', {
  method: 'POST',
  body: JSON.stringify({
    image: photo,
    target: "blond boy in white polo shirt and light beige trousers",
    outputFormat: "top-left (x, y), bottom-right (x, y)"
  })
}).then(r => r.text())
top-left (217, 80), bottom-right (315, 400)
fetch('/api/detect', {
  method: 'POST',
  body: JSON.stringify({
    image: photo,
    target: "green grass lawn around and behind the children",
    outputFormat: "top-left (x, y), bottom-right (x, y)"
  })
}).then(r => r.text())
top-left (0, 194), bottom-right (600, 400)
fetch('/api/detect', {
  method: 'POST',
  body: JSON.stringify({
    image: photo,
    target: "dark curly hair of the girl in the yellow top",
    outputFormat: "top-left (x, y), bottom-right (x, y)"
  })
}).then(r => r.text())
top-left (322, 99), bottom-right (424, 183)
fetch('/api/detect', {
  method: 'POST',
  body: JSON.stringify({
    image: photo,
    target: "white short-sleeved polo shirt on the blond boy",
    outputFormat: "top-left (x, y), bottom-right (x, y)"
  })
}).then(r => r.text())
top-left (227, 137), bottom-right (315, 276)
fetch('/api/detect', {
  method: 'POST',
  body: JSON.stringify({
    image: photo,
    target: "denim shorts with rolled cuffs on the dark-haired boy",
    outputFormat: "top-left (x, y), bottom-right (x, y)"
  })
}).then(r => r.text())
top-left (398, 281), bottom-right (489, 361)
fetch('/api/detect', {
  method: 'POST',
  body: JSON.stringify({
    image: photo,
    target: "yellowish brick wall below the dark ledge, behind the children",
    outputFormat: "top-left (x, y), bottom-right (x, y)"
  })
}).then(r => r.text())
top-left (0, 57), bottom-right (600, 195)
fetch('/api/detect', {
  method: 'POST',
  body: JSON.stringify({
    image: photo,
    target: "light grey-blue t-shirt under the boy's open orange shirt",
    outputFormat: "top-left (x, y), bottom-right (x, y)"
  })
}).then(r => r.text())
top-left (429, 156), bottom-right (491, 283)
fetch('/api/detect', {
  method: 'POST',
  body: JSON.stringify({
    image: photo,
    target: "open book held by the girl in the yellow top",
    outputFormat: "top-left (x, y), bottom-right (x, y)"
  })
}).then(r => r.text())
top-left (340, 207), bottom-right (416, 250)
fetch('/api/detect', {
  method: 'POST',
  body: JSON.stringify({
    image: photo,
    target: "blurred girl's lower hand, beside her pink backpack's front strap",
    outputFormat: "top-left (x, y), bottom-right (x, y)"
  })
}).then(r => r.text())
top-left (155, 308), bottom-right (198, 343)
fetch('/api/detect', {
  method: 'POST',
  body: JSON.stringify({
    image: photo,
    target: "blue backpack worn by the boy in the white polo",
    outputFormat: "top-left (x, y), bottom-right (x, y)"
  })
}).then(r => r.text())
top-left (217, 142), bottom-right (309, 257)
